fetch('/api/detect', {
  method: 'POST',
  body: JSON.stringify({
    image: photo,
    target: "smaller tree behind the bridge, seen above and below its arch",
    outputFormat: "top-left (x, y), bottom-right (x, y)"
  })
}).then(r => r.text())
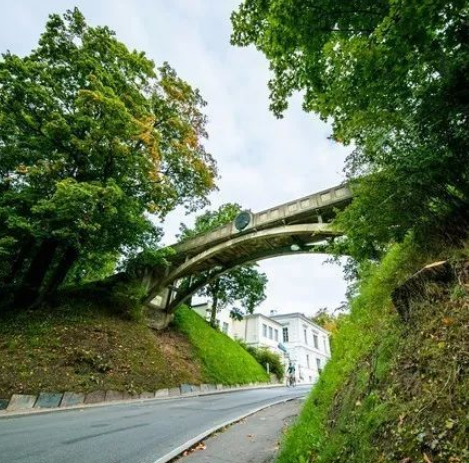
top-left (180, 203), bottom-right (267, 326)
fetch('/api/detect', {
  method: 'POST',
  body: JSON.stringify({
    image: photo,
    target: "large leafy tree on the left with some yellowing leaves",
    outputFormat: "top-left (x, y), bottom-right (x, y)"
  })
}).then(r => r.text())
top-left (0, 8), bottom-right (216, 305)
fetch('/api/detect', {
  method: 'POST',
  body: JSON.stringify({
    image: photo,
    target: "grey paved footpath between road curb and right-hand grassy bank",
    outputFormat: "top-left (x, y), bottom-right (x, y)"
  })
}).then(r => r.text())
top-left (177, 400), bottom-right (302, 463)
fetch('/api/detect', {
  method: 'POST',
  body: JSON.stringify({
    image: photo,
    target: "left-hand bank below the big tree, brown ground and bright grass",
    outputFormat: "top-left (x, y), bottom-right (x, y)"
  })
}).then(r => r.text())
top-left (0, 297), bottom-right (267, 398)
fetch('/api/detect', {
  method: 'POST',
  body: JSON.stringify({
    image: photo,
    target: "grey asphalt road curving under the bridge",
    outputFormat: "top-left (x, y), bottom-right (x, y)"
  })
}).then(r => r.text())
top-left (0, 387), bottom-right (309, 463)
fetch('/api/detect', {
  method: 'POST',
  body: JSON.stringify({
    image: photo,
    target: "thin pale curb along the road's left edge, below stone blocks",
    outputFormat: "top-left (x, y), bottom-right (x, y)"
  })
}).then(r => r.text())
top-left (0, 384), bottom-right (285, 420)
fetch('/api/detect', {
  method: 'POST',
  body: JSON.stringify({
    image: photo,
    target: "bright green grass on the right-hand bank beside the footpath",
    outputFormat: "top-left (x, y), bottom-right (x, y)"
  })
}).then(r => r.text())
top-left (278, 241), bottom-right (458, 463)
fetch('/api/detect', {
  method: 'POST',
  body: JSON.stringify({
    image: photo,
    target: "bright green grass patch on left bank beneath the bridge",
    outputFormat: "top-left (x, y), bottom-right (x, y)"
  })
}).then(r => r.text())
top-left (174, 307), bottom-right (269, 384)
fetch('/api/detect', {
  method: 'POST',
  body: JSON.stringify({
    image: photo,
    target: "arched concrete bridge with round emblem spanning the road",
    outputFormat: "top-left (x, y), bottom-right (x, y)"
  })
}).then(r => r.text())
top-left (143, 184), bottom-right (352, 324)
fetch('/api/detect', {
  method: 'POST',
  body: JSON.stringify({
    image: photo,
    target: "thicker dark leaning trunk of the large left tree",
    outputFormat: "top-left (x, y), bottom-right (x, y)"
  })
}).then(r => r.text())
top-left (14, 239), bottom-right (58, 306)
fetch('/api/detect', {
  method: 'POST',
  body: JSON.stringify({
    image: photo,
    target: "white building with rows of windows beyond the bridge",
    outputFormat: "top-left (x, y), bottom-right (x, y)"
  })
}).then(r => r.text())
top-left (192, 303), bottom-right (331, 384)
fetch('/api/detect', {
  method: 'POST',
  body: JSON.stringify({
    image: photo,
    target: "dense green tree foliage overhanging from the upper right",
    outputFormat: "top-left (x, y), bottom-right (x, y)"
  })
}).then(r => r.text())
top-left (232, 0), bottom-right (469, 259)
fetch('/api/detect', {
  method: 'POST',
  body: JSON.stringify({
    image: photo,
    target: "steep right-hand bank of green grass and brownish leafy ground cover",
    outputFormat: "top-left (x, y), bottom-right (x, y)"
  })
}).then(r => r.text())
top-left (278, 243), bottom-right (469, 463)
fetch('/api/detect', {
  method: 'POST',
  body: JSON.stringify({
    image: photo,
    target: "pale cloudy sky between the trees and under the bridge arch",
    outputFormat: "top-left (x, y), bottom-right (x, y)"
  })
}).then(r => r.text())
top-left (0, 0), bottom-right (348, 314)
